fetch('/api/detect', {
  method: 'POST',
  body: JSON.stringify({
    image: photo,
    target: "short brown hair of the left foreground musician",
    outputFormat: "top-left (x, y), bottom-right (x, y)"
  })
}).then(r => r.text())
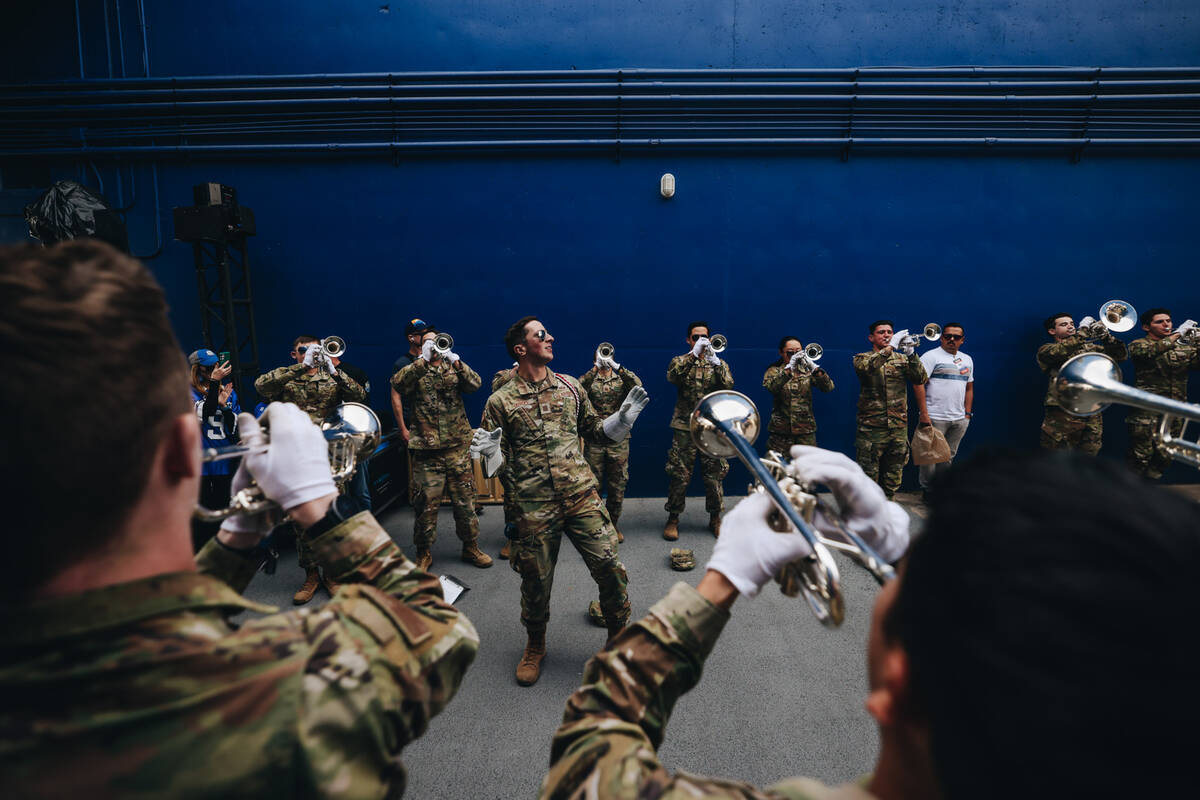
top-left (0, 240), bottom-right (190, 600)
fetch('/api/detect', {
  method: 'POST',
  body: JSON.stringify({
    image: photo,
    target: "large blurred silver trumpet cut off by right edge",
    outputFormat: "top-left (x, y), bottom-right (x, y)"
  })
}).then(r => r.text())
top-left (1054, 353), bottom-right (1200, 469)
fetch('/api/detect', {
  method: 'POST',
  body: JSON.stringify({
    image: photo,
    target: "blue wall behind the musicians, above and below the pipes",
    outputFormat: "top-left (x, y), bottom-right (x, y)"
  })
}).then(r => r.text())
top-left (7, 0), bottom-right (1200, 495)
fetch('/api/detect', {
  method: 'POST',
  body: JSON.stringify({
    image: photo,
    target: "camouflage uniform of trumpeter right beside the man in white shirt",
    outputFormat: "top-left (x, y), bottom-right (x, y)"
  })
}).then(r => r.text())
top-left (854, 349), bottom-right (929, 500)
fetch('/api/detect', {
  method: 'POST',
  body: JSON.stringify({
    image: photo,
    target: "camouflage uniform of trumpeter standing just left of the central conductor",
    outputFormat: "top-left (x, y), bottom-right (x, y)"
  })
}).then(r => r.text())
top-left (391, 359), bottom-right (484, 553)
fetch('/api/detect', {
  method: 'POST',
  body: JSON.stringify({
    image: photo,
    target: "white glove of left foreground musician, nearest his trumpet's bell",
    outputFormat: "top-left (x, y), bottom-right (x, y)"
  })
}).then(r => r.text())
top-left (238, 403), bottom-right (337, 511)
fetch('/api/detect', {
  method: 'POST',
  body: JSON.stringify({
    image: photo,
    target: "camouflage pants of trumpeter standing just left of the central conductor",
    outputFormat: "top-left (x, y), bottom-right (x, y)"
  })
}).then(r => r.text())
top-left (412, 445), bottom-right (479, 551)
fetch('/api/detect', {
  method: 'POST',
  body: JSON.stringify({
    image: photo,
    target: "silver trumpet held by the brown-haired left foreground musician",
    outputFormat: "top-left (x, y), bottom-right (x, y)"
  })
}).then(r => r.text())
top-left (192, 403), bottom-right (382, 522)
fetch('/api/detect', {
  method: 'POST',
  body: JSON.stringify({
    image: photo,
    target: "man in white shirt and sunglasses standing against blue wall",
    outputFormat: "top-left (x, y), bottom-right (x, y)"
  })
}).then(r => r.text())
top-left (913, 323), bottom-right (974, 493)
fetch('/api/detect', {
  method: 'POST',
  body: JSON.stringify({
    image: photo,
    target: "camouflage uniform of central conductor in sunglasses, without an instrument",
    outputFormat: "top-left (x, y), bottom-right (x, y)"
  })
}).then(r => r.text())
top-left (482, 372), bottom-right (629, 634)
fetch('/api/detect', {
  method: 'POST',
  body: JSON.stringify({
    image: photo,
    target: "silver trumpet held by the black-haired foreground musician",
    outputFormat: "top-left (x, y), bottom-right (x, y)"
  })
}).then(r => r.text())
top-left (688, 390), bottom-right (895, 627)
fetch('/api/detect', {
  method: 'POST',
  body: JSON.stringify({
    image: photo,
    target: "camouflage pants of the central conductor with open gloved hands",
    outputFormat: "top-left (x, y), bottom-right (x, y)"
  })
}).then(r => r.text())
top-left (509, 489), bottom-right (629, 631)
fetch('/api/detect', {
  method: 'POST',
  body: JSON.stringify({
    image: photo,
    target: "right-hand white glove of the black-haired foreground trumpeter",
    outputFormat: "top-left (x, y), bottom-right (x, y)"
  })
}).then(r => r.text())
top-left (787, 445), bottom-right (908, 564)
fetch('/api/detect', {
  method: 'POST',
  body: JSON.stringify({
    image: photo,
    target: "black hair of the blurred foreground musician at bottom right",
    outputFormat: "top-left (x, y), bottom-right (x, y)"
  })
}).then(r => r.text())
top-left (881, 451), bottom-right (1200, 798)
